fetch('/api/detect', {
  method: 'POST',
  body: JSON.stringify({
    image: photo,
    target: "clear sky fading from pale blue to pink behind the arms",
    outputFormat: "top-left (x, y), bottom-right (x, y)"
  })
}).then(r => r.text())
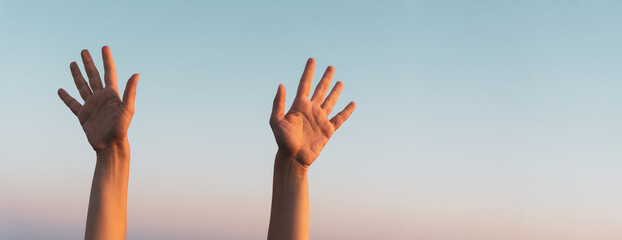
top-left (0, 1), bottom-right (622, 240)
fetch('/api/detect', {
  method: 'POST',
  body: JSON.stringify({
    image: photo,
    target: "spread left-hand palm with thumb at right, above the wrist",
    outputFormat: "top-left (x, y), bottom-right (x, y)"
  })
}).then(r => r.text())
top-left (58, 46), bottom-right (138, 152)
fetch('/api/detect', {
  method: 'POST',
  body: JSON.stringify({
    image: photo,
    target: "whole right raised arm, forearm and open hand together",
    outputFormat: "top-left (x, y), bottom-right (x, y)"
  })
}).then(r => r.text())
top-left (268, 58), bottom-right (356, 240)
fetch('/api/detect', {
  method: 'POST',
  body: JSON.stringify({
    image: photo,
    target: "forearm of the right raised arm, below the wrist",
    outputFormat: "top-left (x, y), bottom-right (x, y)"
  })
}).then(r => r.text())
top-left (268, 152), bottom-right (309, 240)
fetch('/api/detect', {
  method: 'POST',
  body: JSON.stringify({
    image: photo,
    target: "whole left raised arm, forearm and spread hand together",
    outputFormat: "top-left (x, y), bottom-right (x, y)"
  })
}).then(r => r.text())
top-left (58, 46), bottom-right (138, 240)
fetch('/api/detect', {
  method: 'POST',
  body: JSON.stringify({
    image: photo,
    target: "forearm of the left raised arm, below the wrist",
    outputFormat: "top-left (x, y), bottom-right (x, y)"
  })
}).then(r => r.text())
top-left (85, 139), bottom-right (130, 240)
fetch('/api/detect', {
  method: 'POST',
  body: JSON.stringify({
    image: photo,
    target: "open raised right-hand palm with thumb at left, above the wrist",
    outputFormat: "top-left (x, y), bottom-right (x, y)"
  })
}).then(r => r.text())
top-left (270, 58), bottom-right (356, 167)
